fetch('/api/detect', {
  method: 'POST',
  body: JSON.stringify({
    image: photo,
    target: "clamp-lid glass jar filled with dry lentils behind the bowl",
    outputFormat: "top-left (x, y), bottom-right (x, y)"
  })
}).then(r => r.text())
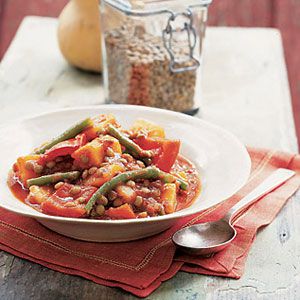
top-left (101, 0), bottom-right (212, 114)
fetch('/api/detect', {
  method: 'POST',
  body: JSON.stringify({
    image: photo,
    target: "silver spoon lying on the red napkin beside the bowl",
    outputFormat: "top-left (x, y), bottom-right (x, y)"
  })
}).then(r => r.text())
top-left (172, 169), bottom-right (295, 255)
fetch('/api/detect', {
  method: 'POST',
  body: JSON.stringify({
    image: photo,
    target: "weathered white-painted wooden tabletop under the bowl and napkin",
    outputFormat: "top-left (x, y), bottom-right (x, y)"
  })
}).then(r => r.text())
top-left (0, 17), bottom-right (300, 300)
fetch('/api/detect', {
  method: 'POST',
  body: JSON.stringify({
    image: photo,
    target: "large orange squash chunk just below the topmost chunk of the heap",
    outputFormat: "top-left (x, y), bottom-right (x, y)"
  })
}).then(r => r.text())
top-left (71, 135), bottom-right (122, 169)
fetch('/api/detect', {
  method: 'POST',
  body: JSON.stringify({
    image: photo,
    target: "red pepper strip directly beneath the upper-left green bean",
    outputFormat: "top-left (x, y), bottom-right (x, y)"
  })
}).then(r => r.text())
top-left (39, 133), bottom-right (87, 165)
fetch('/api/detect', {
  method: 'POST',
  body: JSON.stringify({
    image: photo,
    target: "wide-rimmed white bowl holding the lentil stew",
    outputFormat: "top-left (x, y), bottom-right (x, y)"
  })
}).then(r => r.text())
top-left (0, 105), bottom-right (251, 242)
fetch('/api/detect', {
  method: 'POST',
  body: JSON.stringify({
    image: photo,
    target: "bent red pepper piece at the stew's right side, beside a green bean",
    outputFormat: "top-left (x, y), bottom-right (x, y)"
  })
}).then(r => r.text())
top-left (134, 137), bottom-right (180, 172)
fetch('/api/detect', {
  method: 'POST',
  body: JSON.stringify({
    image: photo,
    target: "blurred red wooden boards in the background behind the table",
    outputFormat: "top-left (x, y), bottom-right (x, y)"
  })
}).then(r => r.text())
top-left (0, 0), bottom-right (300, 148)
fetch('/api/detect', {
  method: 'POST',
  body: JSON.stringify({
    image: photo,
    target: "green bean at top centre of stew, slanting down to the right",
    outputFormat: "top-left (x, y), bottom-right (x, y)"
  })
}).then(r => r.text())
top-left (108, 125), bottom-right (153, 159)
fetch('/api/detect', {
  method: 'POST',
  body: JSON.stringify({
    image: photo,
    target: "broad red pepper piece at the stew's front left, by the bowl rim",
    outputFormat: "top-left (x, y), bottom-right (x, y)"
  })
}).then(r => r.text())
top-left (41, 183), bottom-right (97, 218)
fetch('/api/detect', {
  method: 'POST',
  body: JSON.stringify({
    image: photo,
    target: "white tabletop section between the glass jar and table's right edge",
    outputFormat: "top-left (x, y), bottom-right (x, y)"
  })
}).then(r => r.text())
top-left (203, 27), bottom-right (297, 152)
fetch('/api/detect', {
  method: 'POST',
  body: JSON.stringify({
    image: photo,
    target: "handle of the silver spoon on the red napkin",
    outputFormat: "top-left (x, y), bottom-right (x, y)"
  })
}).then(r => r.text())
top-left (224, 168), bottom-right (295, 224)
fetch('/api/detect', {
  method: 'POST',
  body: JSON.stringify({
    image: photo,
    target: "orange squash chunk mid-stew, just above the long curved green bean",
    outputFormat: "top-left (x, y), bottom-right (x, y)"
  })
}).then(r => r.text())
top-left (83, 164), bottom-right (125, 187)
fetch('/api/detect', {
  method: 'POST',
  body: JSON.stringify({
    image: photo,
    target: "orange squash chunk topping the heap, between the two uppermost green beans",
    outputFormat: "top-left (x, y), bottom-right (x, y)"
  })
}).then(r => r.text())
top-left (83, 114), bottom-right (118, 141)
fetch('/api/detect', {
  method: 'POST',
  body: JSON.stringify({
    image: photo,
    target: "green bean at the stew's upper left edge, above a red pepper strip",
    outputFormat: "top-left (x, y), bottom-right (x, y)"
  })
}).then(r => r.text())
top-left (34, 118), bottom-right (93, 154)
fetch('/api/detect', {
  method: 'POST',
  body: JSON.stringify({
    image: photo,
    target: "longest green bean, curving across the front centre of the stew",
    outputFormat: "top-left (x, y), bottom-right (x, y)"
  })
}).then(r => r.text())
top-left (85, 167), bottom-right (160, 212)
